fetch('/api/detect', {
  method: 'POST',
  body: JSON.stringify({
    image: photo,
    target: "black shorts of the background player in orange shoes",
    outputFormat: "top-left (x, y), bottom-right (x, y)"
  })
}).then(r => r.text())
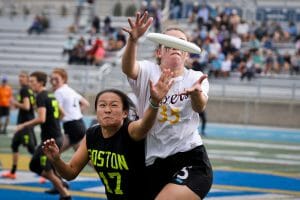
top-left (11, 128), bottom-right (36, 154)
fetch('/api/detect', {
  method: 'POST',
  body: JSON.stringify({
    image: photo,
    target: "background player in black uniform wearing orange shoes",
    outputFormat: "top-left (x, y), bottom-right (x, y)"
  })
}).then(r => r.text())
top-left (2, 72), bottom-right (36, 179)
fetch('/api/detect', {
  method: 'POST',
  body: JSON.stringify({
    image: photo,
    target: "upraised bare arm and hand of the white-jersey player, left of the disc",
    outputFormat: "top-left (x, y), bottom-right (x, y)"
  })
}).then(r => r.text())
top-left (122, 12), bottom-right (153, 80)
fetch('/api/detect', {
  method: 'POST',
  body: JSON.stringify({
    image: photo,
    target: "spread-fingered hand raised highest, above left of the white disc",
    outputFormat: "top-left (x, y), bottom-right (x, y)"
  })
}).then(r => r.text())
top-left (122, 11), bottom-right (153, 42)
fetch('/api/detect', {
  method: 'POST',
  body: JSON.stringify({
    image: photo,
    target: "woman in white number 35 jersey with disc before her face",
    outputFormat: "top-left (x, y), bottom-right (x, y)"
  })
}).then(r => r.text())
top-left (122, 12), bottom-right (213, 200)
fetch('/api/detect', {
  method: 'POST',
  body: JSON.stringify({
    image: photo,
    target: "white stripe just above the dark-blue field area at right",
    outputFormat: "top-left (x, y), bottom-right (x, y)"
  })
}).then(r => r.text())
top-left (209, 154), bottom-right (300, 166)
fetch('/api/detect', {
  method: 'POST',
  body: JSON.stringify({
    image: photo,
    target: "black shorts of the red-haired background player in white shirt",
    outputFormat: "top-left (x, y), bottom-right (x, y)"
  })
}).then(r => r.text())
top-left (63, 119), bottom-right (86, 144)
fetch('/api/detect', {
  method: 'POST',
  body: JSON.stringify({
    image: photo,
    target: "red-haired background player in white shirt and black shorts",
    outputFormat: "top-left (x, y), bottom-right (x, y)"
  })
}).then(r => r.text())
top-left (50, 68), bottom-right (90, 152)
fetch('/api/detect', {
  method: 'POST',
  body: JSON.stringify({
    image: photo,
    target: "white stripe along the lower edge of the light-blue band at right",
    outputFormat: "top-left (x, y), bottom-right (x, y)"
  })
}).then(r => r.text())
top-left (204, 139), bottom-right (300, 151)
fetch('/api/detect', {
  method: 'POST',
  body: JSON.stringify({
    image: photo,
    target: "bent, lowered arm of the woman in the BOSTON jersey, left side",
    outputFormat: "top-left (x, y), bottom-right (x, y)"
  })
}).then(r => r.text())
top-left (43, 137), bottom-right (89, 180)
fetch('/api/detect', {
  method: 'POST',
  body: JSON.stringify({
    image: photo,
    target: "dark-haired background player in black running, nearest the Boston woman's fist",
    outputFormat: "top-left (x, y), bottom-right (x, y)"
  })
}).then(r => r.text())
top-left (17, 72), bottom-right (71, 199)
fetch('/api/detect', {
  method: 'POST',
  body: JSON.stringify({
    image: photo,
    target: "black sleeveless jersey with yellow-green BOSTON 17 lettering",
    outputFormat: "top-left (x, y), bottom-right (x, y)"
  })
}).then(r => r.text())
top-left (86, 122), bottom-right (145, 200)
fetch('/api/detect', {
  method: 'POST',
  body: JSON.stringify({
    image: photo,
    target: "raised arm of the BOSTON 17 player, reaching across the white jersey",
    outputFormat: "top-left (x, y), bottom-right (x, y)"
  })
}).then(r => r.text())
top-left (128, 69), bottom-right (173, 140)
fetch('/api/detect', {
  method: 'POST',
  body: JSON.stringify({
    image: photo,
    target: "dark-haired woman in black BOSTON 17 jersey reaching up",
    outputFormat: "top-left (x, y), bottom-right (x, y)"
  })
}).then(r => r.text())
top-left (43, 70), bottom-right (173, 200)
